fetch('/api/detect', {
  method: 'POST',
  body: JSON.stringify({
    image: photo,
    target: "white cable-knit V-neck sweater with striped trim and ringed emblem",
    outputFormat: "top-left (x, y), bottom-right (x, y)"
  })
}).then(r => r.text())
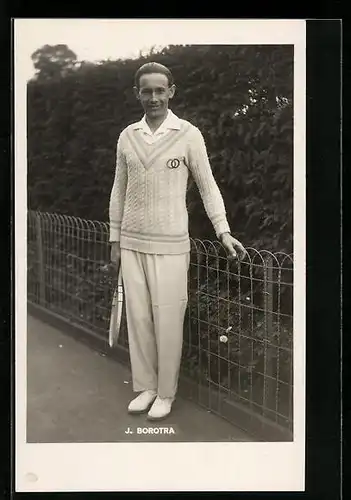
top-left (109, 113), bottom-right (230, 254)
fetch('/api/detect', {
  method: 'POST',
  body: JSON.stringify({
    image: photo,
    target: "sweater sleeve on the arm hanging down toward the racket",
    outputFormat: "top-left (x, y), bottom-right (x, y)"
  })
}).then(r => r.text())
top-left (109, 134), bottom-right (128, 242)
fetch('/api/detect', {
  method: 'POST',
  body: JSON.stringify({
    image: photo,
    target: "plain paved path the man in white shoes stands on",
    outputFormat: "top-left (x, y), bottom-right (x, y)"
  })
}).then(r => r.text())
top-left (27, 316), bottom-right (251, 443)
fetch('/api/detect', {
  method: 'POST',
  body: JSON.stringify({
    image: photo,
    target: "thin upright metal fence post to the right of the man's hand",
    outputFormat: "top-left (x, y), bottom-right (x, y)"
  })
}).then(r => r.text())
top-left (264, 255), bottom-right (275, 409)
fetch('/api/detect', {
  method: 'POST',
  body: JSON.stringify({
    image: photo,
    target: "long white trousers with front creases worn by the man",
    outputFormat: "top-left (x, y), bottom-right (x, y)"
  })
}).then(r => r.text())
top-left (121, 248), bottom-right (190, 398)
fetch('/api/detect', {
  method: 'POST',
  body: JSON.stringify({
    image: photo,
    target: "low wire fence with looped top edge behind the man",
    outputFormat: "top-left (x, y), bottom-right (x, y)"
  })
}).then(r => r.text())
top-left (27, 211), bottom-right (293, 439)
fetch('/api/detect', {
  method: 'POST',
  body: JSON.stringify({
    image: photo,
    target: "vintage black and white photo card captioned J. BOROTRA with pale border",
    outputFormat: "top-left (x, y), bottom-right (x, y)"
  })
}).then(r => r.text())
top-left (15, 19), bottom-right (305, 492)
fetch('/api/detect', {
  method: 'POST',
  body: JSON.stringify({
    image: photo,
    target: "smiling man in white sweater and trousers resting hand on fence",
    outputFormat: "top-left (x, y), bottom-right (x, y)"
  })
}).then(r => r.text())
top-left (109, 63), bottom-right (245, 420)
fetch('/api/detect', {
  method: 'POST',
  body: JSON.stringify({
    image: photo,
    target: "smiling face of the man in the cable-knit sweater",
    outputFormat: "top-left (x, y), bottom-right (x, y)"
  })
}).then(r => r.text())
top-left (136, 73), bottom-right (175, 118)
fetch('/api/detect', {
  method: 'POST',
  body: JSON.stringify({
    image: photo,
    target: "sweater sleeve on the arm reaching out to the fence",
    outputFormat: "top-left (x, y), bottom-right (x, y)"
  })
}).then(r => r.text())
top-left (188, 127), bottom-right (230, 238)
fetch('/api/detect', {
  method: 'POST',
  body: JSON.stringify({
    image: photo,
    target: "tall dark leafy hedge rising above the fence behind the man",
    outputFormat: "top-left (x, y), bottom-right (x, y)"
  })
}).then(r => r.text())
top-left (28, 46), bottom-right (293, 252)
